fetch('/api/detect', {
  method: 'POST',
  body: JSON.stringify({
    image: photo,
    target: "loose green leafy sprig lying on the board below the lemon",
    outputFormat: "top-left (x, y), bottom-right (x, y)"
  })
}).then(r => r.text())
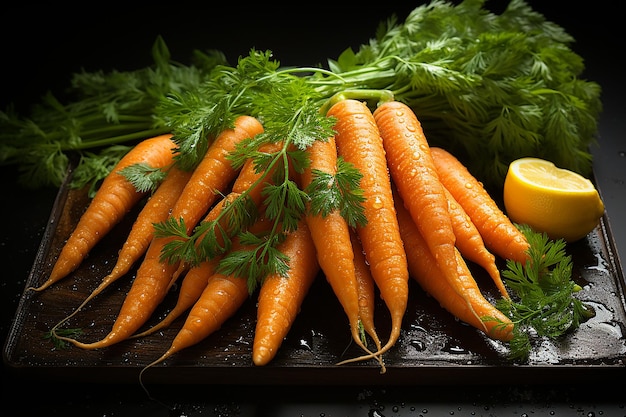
top-left (496, 225), bottom-right (595, 359)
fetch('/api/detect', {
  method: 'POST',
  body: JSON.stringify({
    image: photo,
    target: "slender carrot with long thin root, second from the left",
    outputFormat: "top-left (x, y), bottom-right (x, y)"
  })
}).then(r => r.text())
top-left (52, 166), bottom-right (191, 334)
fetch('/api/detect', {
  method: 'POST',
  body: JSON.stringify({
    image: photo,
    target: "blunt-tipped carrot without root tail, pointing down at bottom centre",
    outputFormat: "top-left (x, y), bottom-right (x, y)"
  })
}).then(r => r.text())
top-left (252, 221), bottom-right (320, 366)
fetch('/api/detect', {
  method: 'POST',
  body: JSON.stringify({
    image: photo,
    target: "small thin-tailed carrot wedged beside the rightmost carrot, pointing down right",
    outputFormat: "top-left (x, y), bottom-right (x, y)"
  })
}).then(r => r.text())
top-left (444, 188), bottom-right (510, 299)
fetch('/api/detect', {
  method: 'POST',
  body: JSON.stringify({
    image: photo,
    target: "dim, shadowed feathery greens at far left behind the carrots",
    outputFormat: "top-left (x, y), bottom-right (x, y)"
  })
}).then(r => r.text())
top-left (0, 38), bottom-right (224, 191)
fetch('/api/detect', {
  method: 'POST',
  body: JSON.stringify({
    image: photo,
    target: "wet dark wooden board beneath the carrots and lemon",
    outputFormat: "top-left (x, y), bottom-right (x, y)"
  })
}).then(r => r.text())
top-left (3, 164), bottom-right (626, 385)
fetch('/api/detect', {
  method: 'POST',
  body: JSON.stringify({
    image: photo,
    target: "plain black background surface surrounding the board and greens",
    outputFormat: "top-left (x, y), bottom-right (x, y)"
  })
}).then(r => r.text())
top-left (0, 1), bottom-right (626, 417)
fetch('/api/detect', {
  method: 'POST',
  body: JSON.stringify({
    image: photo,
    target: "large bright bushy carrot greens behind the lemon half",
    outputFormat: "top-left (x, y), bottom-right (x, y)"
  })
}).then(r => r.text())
top-left (316, 0), bottom-right (602, 190)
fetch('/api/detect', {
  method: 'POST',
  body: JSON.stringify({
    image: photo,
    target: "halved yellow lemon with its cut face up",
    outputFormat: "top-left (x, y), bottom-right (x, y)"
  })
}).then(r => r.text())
top-left (503, 158), bottom-right (604, 242)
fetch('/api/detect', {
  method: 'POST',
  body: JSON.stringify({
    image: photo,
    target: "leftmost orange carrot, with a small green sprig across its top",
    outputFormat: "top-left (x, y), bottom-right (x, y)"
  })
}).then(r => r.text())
top-left (30, 134), bottom-right (176, 291)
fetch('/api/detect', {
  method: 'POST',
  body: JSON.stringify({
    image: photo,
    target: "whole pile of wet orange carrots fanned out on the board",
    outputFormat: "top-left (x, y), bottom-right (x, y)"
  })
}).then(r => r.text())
top-left (31, 98), bottom-right (528, 372)
